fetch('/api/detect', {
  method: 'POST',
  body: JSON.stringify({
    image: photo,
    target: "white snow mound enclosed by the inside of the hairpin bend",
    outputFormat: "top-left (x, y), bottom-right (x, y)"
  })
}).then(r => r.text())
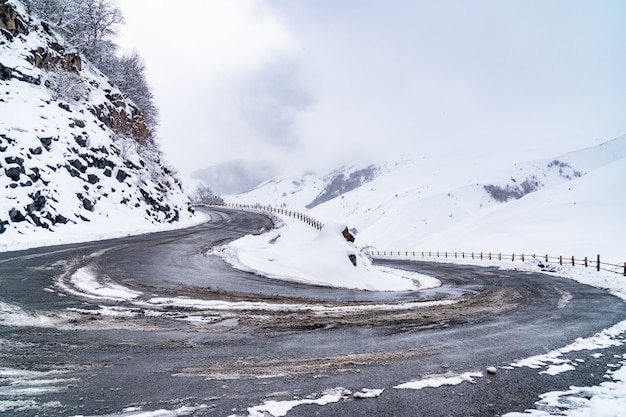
top-left (212, 216), bottom-right (440, 291)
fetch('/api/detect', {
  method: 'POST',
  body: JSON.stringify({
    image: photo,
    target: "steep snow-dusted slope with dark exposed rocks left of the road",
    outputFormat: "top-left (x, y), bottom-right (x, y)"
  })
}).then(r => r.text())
top-left (0, 0), bottom-right (193, 240)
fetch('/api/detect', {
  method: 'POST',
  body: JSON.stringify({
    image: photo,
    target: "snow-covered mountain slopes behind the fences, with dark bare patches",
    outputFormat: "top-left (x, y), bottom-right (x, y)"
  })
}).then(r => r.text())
top-left (226, 136), bottom-right (626, 262)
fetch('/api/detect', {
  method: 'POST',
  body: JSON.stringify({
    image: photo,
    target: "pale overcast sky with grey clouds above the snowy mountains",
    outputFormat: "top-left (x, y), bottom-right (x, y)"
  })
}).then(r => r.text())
top-left (118, 0), bottom-right (626, 177)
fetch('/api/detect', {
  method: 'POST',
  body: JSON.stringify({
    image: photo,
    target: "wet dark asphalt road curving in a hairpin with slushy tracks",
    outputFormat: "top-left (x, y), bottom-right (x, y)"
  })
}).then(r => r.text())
top-left (0, 209), bottom-right (626, 416)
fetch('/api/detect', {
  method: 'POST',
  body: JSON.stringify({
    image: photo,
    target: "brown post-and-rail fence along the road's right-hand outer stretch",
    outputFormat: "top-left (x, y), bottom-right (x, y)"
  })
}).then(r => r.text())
top-left (368, 250), bottom-right (626, 276)
